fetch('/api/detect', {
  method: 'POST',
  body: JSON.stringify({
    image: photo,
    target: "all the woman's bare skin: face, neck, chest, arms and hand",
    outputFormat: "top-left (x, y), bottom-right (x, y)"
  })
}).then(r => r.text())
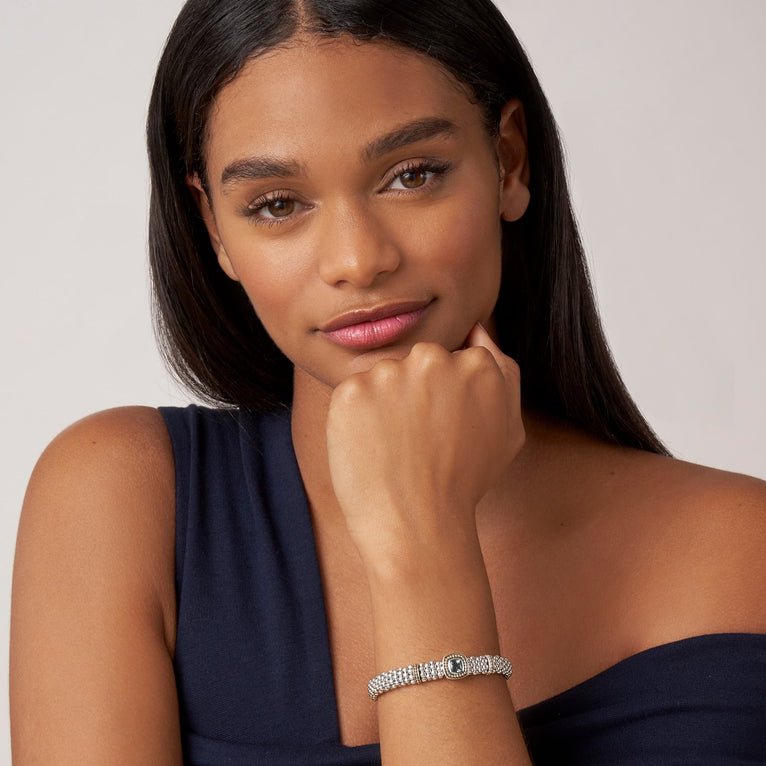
top-left (11, 40), bottom-right (766, 766)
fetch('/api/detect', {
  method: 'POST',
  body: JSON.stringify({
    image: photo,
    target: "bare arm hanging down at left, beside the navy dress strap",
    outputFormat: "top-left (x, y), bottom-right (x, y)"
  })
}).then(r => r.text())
top-left (10, 408), bottom-right (181, 766)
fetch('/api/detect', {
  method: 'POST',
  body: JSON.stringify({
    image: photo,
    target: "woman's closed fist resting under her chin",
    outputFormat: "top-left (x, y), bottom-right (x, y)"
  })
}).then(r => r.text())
top-left (327, 325), bottom-right (524, 576)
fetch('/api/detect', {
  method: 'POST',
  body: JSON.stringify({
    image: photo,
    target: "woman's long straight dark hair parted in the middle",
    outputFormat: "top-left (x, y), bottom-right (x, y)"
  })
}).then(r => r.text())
top-left (147, 0), bottom-right (667, 454)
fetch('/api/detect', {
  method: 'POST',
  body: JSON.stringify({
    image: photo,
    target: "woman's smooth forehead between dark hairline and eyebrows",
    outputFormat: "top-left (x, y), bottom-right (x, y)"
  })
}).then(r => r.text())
top-left (205, 38), bottom-right (483, 168)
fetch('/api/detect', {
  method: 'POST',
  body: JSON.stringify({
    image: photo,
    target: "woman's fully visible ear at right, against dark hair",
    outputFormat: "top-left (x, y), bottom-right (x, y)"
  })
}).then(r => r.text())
top-left (496, 98), bottom-right (529, 221)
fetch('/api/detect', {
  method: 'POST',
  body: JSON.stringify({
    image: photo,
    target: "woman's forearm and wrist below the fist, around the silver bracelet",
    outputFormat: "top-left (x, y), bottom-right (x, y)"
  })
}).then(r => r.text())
top-left (370, 541), bottom-right (530, 766)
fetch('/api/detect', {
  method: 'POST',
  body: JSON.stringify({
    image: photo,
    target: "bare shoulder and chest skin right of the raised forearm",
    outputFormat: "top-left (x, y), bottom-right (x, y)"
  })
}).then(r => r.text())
top-left (496, 421), bottom-right (766, 704)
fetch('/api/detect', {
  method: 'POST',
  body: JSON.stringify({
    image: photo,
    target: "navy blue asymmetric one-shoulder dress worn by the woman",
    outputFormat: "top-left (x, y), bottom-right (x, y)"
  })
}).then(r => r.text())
top-left (160, 406), bottom-right (766, 766)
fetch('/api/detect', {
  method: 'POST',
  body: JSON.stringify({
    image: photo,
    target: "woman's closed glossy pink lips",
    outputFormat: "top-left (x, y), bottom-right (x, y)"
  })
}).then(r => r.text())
top-left (320, 301), bottom-right (431, 349)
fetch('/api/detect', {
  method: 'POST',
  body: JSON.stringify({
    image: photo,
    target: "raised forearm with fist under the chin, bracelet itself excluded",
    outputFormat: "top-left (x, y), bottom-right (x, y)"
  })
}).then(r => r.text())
top-left (328, 330), bottom-right (530, 766)
